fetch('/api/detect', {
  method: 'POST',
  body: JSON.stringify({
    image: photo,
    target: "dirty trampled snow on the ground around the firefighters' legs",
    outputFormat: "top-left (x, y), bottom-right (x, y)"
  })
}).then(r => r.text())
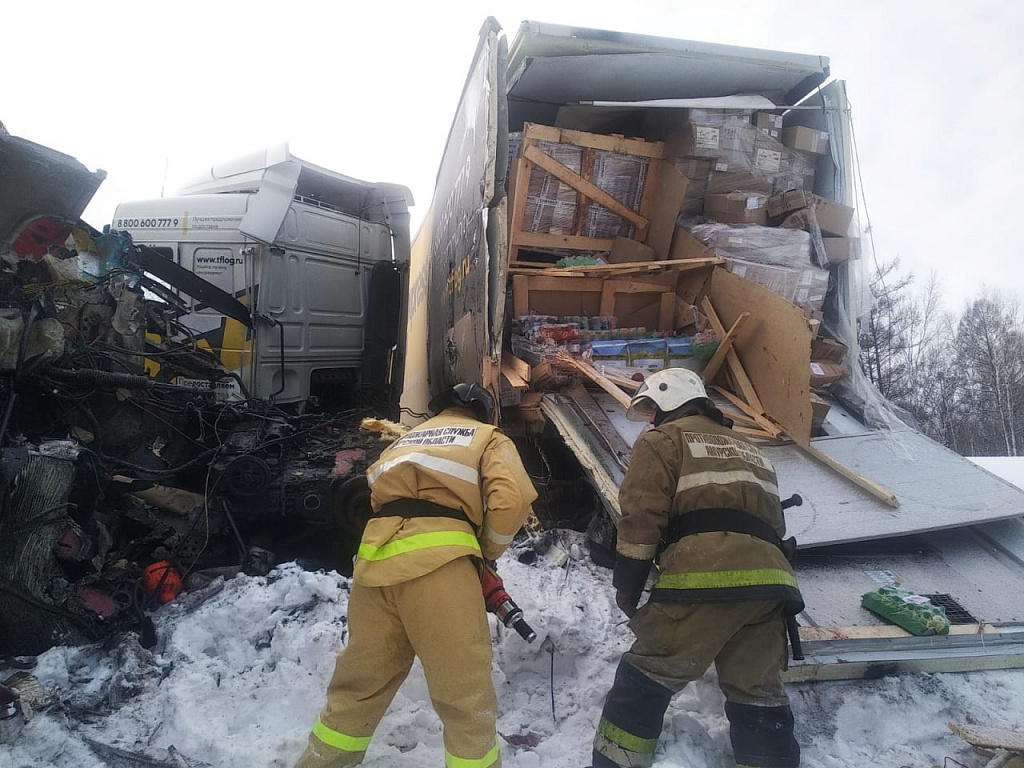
top-left (0, 532), bottom-right (1024, 768)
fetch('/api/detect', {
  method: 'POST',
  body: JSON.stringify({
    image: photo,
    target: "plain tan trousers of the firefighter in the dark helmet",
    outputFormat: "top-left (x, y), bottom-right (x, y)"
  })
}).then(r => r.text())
top-left (296, 557), bottom-right (501, 768)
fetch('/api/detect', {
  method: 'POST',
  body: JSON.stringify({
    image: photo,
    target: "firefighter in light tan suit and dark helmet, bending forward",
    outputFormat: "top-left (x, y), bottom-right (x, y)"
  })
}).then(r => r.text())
top-left (296, 384), bottom-right (537, 768)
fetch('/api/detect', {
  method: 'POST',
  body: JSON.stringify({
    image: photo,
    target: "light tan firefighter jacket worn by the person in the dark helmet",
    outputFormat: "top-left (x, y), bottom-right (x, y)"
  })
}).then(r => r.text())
top-left (353, 409), bottom-right (537, 587)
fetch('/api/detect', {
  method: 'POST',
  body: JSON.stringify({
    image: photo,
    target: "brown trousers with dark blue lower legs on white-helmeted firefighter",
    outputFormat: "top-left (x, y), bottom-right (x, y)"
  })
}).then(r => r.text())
top-left (593, 601), bottom-right (800, 768)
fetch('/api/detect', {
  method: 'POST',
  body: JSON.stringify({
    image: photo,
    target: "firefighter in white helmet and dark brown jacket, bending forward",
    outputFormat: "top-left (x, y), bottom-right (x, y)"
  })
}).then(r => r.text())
top-left (593, 369), bottom-right (803, 768)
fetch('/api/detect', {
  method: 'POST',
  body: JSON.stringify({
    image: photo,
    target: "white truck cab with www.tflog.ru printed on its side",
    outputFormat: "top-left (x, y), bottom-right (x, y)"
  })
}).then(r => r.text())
top-left (112, 145), bottom-right (413, 408)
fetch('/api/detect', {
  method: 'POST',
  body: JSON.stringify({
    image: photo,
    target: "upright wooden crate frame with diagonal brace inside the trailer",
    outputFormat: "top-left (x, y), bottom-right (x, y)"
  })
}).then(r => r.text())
top-left (509, 123), bottom-right (665, 266)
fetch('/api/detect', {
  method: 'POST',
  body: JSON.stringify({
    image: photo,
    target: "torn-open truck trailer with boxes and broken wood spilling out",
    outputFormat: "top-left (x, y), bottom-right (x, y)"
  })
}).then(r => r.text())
top-left (402, 19), bottom-right (1024, 680)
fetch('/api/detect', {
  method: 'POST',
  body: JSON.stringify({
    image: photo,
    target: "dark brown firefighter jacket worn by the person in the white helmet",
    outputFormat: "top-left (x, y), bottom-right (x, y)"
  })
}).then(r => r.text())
top-left (615, 416), bottom-right (802, 610)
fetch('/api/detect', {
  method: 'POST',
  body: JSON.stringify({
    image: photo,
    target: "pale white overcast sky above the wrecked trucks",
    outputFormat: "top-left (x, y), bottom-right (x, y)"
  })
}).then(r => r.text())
top-left (0, 0), bottom-right (1024, 310)
